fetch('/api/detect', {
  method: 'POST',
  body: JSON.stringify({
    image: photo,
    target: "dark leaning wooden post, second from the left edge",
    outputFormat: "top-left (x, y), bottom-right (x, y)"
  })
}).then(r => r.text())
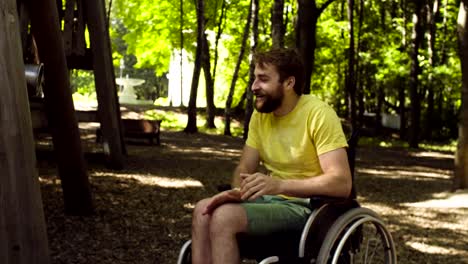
top-left (26, 0), bottom-right (93, 215)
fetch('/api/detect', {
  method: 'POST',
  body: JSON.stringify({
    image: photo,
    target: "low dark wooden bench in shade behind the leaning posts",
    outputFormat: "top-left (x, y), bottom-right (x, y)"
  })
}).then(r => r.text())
top-left (96, 119), bottom-right (162, 145)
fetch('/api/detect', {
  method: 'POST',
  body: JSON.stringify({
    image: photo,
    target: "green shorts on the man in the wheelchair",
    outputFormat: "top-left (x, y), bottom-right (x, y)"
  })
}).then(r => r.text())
top-left (241, 195), bottom-right (312, 235)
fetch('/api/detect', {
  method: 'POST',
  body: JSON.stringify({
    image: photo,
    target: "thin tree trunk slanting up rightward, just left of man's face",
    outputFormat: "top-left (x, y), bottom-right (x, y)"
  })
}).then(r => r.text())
top-left (224, 0), bottom-right (253, 136)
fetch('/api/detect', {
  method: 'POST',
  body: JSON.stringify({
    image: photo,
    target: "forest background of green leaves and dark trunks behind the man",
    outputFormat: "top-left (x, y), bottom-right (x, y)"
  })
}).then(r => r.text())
top-left (71, 0), bottom-right (462, 187)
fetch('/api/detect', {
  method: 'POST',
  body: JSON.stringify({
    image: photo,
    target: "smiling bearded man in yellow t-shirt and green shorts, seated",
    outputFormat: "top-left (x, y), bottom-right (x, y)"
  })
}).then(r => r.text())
top-left (191, 49), bottom-right (352, 264)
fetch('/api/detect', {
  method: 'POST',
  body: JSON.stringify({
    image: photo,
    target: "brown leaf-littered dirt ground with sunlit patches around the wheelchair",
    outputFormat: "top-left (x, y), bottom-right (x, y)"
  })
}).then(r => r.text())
top-left (37, 131), bottom-right (468, 264)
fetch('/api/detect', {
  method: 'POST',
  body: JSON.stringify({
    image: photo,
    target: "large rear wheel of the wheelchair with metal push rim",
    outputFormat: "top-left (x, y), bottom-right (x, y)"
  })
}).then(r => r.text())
top-left (316, 208), bottom-right (397, 264)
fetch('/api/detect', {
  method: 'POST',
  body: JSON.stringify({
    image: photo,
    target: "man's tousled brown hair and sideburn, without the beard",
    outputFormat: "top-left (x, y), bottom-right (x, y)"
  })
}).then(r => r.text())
top-left (254, 48), bottom-right (304, 95)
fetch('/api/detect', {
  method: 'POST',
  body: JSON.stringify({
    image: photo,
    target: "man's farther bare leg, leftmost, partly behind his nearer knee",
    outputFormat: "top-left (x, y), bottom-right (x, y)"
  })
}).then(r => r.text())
top-left (192, 198), bottom-right (212, 264)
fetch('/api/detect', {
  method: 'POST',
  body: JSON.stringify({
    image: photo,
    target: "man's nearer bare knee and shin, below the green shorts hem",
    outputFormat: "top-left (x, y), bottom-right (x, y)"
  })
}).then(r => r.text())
top-left (209, 203), bottom-right (248, 264)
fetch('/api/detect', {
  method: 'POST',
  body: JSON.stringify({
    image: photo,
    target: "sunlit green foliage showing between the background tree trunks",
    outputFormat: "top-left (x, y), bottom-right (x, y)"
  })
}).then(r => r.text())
top-left (104, 0), bottom-right (461, 142)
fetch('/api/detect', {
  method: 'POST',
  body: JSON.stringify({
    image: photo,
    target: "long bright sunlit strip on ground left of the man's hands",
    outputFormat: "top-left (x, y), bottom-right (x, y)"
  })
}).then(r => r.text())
top-left (92, 172), bottom-right (203, 189)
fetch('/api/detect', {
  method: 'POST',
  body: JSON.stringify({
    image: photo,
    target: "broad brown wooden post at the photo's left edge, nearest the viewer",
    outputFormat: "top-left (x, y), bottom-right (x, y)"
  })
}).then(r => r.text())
top-left (0, 0), bottom-right (50, 264)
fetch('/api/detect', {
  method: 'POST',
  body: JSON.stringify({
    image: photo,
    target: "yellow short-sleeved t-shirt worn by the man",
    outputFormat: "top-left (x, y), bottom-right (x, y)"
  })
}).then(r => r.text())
top-left (246, 95), bottom-right (347, 179)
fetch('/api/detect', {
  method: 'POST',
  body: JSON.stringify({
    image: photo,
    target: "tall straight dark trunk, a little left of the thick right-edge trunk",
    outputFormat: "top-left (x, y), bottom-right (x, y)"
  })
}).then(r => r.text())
top-left (408, 1), bottom-right (424, 148)
